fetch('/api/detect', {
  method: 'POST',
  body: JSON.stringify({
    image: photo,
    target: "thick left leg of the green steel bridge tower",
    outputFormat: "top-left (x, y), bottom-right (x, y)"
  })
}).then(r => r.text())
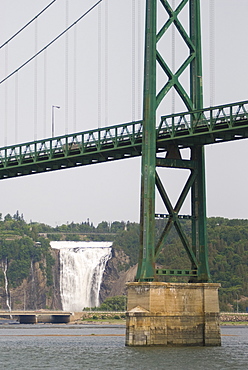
top-left (137, 0), bottom-right (157, 281)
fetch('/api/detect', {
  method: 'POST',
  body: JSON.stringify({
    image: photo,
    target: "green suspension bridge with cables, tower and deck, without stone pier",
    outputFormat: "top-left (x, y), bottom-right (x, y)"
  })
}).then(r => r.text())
top-left (0, 0), bottom-right (248, 282)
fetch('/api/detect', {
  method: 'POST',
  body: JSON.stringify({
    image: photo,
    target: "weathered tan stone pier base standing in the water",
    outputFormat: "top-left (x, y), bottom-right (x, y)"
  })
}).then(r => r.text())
top-left (126, 283), bottom-right (221, 346)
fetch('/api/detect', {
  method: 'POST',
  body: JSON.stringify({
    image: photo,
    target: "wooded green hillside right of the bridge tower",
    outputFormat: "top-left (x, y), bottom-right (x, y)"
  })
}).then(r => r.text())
top-left (208, 217), bottom-right (248, 312)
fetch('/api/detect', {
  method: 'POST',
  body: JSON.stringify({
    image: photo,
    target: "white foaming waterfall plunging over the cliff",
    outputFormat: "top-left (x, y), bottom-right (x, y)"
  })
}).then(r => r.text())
top-left (50, 241), bottom-right (112, 311)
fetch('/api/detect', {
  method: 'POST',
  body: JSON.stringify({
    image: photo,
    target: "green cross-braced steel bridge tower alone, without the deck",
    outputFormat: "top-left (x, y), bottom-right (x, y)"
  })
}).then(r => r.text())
top-left (137, 0), bottom-right (209, 282)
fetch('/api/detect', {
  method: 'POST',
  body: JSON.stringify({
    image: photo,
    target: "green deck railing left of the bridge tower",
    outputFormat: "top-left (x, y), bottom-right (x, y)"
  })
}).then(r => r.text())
top-left (0, 121), bottom-right (142, 168)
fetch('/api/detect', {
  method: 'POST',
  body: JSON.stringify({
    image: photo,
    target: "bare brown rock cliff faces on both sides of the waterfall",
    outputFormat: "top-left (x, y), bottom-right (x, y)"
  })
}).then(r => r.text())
top-left (0, 249), bottom-right (134, 310)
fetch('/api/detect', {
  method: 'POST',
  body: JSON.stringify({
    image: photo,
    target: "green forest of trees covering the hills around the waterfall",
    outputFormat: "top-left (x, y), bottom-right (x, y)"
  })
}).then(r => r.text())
top-left (0, 211), bottom-right (248, 311)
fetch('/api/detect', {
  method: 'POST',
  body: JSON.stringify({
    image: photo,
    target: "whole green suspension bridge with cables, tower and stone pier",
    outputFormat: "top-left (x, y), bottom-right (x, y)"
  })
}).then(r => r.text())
top-left (0, 0), bottom-right (248, 345)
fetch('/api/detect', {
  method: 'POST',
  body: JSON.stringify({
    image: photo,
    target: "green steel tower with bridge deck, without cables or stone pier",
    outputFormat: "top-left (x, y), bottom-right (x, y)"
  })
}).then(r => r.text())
top-left (0, 0), bottom-right (248, 282)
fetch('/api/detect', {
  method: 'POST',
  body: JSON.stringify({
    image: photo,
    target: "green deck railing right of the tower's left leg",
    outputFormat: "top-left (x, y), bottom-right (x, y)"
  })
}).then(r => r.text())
top-left (157, 101), bottom-right (248, 138)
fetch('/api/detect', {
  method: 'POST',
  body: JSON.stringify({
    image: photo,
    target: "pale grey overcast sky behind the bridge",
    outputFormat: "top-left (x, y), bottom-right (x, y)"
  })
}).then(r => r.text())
top-left (0, 0), bottom-right (248, 226)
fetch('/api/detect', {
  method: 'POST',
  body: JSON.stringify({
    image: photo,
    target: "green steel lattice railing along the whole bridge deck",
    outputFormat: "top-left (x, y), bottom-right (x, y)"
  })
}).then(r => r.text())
top-left (0, 101), bottom-right (248, 169)
